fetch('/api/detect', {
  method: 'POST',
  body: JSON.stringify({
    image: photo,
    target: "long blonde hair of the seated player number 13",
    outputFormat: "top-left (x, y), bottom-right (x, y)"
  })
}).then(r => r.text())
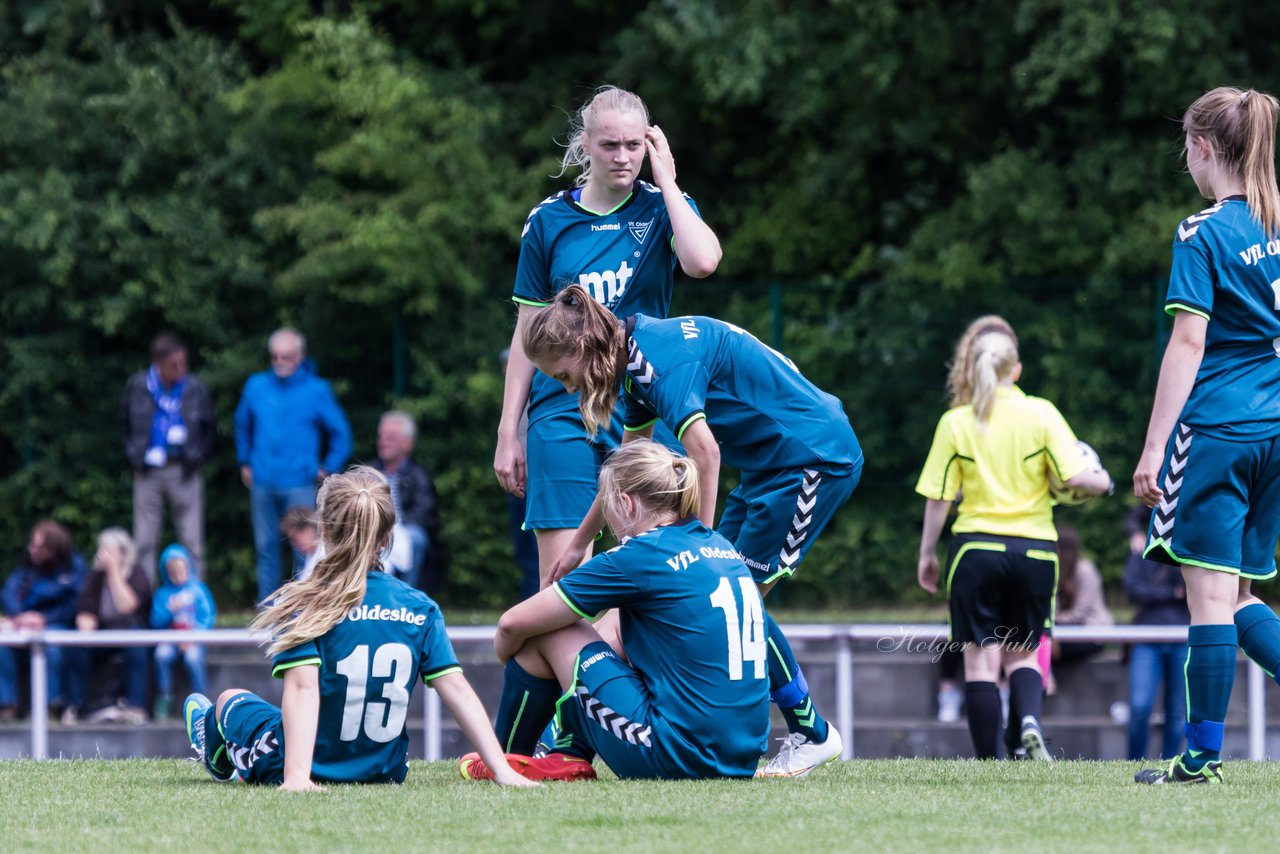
top-left (252, 466), bottom-right (396, 656)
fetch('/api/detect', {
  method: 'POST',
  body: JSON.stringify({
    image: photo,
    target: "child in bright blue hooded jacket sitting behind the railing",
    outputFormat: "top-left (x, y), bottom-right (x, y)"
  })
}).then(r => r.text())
top-left (151, 544), bottom-right (216, 721)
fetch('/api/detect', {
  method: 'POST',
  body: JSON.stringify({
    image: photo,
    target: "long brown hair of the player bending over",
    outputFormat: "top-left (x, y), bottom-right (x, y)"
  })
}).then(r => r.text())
top-left (521, 284), bottom-right (626, 439)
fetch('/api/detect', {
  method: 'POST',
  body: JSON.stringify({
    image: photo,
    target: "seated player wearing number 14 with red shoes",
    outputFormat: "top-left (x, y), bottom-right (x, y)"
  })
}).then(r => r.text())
top-left (458, 440), bottom-right (769, 780)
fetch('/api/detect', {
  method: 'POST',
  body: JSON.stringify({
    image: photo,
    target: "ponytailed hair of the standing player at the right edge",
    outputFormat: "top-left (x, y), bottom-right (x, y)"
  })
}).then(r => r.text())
top-left (1183, 86), bottom-right (1280, 237)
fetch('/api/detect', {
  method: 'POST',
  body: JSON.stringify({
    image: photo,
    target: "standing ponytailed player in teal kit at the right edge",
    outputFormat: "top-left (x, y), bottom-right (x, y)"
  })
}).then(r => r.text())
top-left (1133, 87), bottom-right (1280, 784)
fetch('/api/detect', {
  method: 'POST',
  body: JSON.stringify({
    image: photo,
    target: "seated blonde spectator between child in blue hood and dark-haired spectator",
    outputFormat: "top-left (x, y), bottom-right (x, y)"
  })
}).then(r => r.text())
top-left (63, 528), bottom-right (151, 723)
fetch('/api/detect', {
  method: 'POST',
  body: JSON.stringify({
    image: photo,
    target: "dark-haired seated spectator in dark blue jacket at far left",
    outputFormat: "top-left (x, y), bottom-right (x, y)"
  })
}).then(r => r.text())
top-left (0, 519), bottom-right (84, 721)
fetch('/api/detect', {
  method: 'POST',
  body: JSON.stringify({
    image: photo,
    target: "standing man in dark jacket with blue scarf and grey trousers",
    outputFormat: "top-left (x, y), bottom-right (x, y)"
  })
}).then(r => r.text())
top-left (120, 332), bottom-right (216, 588)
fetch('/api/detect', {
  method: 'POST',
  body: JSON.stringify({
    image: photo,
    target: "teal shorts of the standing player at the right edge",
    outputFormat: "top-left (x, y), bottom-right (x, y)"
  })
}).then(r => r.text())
top-left (1144, 424), bottom-right (1280, 580)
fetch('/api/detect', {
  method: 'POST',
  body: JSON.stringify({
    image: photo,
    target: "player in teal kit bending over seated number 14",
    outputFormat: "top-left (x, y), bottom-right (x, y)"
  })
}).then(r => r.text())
top-left (524, 286), bottom-right (863, 777)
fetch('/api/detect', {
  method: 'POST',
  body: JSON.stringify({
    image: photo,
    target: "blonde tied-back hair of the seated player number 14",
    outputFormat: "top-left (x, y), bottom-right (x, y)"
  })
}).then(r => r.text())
top-left (600, 439), bottom-right (701, 536)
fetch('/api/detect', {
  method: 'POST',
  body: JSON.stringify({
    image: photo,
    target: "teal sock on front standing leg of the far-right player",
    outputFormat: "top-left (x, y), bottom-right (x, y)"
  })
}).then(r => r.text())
top-left (1183, 624), bottom-right (1236, 771)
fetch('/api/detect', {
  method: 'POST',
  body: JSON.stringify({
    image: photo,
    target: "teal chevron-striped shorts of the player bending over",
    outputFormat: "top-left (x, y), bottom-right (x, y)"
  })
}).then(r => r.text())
top-left (716, 460), bottom-right (863, 584)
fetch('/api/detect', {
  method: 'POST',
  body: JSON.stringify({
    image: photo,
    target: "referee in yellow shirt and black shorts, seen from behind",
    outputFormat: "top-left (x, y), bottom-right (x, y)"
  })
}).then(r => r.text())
top-left (915, 315), bottom-right (1111, 759)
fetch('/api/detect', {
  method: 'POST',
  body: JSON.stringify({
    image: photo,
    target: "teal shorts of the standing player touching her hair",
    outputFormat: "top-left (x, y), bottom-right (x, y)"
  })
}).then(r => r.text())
top-left (525, 405), bottom-right (684, 531)
